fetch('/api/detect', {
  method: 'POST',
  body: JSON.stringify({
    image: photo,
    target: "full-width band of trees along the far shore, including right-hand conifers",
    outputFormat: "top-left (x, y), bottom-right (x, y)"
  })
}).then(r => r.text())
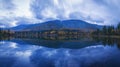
top-left (0, 23), bottom-right (120, 38)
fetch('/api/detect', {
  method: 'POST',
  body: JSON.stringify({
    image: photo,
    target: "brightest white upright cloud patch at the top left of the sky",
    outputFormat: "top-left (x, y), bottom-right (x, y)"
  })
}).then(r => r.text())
top-left (14, 0), bottom-right (32, 18)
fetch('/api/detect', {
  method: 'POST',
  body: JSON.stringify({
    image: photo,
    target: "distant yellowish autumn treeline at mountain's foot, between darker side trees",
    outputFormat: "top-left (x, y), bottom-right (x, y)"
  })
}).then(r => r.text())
top-left (14, 29), bottom-right (85, 37)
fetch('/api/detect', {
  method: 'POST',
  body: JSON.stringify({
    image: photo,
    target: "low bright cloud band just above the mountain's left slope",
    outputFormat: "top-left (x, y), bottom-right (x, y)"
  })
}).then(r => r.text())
top-left (0, 17), bottom-right (42, 28)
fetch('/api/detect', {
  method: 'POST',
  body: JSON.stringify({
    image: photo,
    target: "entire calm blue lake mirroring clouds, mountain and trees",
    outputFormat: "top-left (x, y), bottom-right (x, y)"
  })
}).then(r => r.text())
top-left (0, 38), bottom-right (120, 67)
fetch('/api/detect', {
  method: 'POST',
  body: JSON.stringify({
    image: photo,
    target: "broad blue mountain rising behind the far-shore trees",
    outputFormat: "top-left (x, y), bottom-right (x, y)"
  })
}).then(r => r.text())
top-left (8, 20), bottom-right (102, 31)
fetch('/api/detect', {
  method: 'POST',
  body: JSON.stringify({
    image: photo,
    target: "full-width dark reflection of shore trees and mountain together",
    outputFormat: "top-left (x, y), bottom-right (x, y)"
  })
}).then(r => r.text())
top-left (0, 36), bottom-right (120, 48)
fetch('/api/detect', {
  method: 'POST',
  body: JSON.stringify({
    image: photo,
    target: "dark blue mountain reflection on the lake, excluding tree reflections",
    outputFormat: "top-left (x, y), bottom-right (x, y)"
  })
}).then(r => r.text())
top-left (11, 39), bottom-right (99, 49)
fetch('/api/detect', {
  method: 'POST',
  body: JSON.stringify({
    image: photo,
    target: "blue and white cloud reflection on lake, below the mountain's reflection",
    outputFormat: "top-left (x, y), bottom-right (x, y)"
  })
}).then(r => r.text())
top-left (0, 41), bottom-right (120, 67)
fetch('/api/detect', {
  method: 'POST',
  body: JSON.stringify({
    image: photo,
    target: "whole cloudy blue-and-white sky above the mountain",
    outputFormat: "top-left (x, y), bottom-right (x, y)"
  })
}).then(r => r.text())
top-left (0, 0), bottom-right (120, 28)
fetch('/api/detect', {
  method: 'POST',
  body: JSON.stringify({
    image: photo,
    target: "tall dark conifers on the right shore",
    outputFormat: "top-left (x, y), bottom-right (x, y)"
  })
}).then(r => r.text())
top-left (92, 23), bottom-right (120, 35)
